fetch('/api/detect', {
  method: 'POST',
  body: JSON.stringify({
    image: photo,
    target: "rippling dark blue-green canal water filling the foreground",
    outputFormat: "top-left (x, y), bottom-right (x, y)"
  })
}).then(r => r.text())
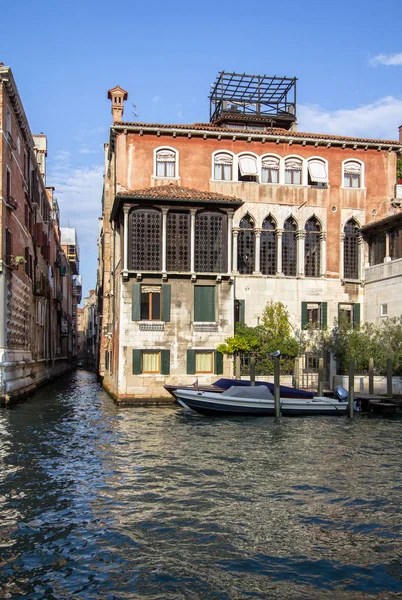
top-left (0, 371), bottom-right (402, 600)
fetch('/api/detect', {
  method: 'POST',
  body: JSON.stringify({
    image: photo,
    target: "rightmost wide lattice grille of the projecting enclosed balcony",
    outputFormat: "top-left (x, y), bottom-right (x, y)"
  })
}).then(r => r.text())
top-left (194, 212), bottom-right (227, 273)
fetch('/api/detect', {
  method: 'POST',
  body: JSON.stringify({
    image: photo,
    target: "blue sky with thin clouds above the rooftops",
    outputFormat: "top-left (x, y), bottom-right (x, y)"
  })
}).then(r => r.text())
top-left (0, 0), bottom-right (402, 296)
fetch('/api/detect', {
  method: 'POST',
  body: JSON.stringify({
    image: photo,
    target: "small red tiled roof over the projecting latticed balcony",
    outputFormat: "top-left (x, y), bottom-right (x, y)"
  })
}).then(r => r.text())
top-left (116, 183), bottom-right (243, 204)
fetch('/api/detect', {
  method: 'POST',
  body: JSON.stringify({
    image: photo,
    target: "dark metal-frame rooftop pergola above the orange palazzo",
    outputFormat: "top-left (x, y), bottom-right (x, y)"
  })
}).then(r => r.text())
top-left (209, 71), bottom-right (297, 124)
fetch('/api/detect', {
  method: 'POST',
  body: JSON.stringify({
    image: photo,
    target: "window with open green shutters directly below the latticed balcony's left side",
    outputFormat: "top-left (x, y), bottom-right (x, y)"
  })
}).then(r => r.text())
top-left (131, 283), bottom-right (171, 322)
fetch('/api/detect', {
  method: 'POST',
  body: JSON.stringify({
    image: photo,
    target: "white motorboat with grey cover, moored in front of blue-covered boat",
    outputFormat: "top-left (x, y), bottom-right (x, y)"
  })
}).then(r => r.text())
top-left (175, 385), bottom-right (348, 416)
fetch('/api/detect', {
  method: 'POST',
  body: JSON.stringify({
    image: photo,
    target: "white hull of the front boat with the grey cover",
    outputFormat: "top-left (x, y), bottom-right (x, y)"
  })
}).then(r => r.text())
top-left (176, 389), bottom-right (348, 416)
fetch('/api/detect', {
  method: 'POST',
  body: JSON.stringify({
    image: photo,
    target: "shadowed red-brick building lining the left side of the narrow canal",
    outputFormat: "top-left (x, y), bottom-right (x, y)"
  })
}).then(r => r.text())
top-left (0, 64), bottom-right (80, 402)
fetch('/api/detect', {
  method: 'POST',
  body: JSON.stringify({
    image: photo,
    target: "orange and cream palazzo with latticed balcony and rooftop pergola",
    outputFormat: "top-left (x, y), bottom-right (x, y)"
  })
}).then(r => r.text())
top-left (98, 73), bottom-right (402, 401)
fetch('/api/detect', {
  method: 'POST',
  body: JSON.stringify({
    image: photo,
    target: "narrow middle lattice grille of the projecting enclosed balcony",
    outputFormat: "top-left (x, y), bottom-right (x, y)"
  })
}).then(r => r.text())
top-left (166, 212), bottom-right (190, 271)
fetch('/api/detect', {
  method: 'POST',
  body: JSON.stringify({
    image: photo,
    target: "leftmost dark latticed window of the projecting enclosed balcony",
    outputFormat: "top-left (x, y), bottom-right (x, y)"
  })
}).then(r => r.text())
top-left (129, 208), bottom-right (162, 271)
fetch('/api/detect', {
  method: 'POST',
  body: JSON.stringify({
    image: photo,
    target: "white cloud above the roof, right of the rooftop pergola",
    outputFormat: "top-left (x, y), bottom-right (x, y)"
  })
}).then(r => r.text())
top-left (297, 96), bottom-right (402, 140)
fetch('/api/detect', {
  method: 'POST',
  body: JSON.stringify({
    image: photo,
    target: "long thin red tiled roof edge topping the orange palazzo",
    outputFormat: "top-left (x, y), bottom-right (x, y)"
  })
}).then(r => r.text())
top-left (114, 121), bottom-right (401, 146)
